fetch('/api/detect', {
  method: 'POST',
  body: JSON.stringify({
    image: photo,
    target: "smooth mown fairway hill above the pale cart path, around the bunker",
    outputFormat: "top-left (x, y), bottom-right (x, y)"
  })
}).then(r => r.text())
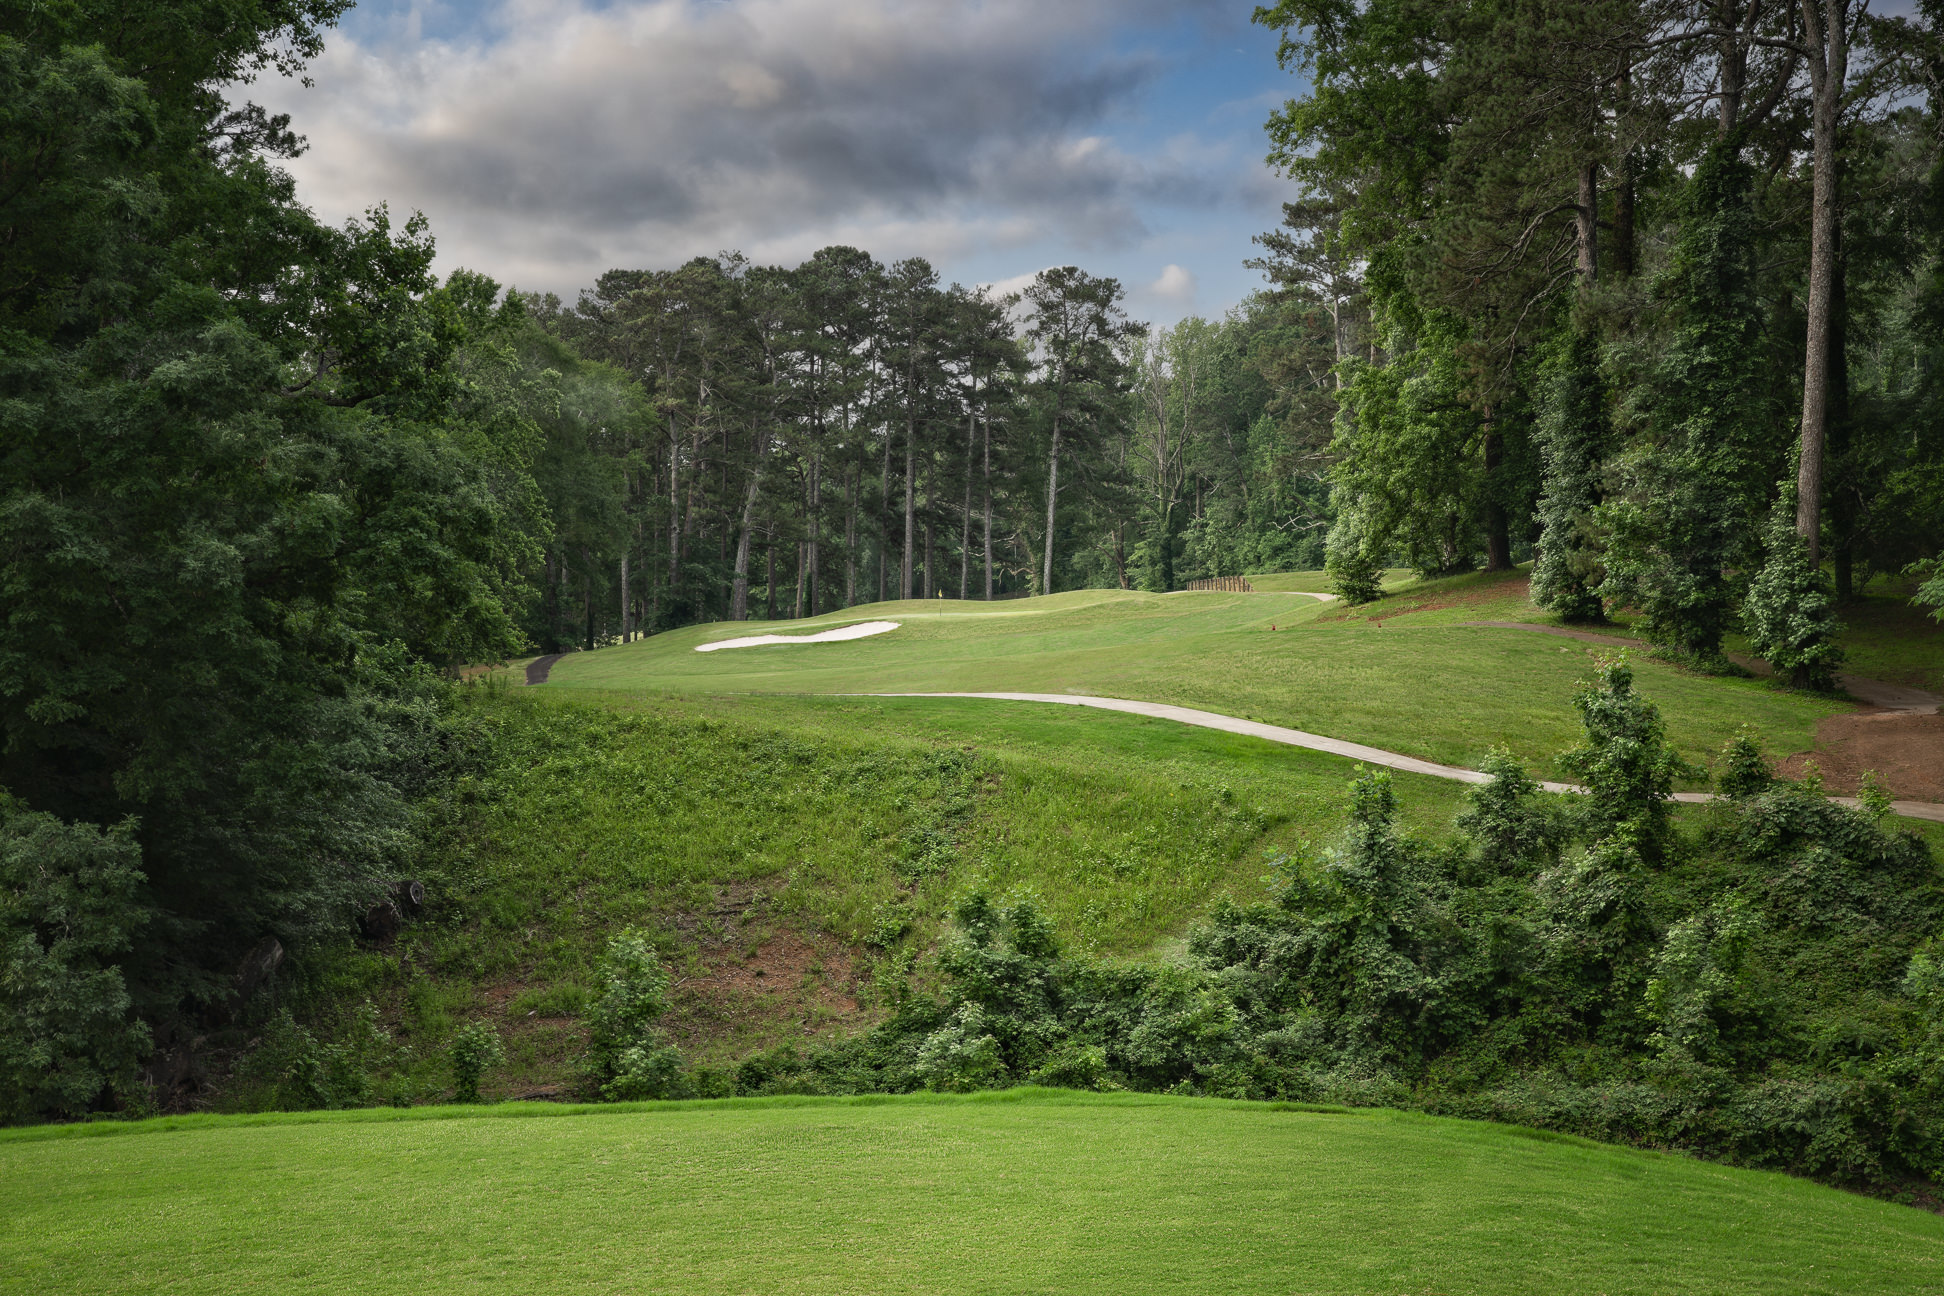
top-left (550, 591), bottom-right (1843, 775)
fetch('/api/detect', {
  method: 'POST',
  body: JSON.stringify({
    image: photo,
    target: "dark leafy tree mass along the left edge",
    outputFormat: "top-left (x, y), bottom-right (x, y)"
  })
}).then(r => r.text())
top-left (0, 0), bottom-right (548, 1117)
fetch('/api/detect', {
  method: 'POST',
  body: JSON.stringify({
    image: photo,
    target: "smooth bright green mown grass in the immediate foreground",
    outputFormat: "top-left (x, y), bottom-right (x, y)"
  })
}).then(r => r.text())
top-left (0, 1090), bottom-right (1944, 1296)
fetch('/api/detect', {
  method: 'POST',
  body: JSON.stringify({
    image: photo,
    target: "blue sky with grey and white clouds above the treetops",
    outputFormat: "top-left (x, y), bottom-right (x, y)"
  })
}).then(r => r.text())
top-left (249, 0), bottom-right (1295, 321)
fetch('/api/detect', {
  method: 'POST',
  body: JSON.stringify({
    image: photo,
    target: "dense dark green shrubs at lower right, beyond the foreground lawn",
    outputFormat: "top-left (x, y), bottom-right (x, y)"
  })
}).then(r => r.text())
top-left (711, 676), bottom-right (1944, 1187)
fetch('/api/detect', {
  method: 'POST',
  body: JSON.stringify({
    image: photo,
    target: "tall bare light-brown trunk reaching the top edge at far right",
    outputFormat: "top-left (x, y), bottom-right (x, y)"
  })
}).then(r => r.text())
top-left (1796, 0), bottom-right (1849, 563)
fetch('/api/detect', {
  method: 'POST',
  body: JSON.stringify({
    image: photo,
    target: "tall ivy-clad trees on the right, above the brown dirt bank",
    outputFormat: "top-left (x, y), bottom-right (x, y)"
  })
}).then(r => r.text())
top-left (1258, 0), bottom-right (1944, 684)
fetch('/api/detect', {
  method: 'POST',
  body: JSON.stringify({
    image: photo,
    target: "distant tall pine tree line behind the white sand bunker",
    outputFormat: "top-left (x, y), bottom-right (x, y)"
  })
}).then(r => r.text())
top-left (515, 247), bottom-right (1328, 651)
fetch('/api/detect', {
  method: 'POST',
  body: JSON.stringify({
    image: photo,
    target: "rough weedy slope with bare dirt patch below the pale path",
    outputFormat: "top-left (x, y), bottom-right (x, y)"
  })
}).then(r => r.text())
top-left (291, 690), bottom-right (1460, 1108)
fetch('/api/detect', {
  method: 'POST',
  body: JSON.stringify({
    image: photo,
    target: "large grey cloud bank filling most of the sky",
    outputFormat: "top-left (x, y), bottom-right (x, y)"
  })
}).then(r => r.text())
top-left (262, 0), bottom-right (1244, 288)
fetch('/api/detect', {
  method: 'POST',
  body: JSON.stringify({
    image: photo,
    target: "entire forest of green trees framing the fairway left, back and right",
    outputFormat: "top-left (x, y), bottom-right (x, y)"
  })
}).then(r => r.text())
top-left (11, 0), bottom-right (1944, 1142)
